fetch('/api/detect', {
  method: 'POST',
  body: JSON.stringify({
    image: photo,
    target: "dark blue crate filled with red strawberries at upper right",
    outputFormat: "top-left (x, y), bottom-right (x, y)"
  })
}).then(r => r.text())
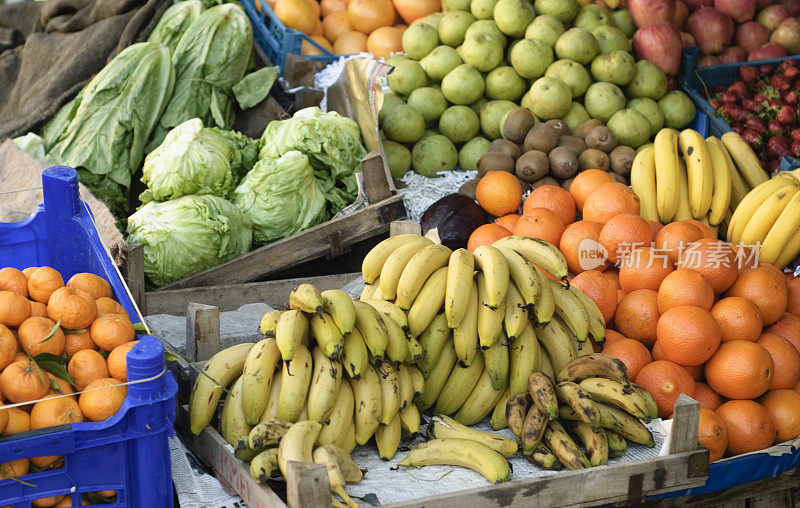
top-left (684, 51), bottom-right (800, 173)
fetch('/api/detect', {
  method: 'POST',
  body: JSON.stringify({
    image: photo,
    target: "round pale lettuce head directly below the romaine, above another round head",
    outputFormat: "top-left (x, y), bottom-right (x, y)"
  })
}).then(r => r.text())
top-left (139, 118), bottom-right (236, 203)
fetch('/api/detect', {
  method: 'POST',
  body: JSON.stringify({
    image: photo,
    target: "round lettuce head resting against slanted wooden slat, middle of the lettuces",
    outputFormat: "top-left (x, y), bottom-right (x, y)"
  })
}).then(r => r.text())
top-left (233, 150), bottom-right (328, 243)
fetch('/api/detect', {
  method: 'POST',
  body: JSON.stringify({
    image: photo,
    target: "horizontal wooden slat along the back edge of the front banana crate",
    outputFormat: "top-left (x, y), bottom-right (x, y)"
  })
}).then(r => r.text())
top-left (146, 272), bottom-right (361, 316)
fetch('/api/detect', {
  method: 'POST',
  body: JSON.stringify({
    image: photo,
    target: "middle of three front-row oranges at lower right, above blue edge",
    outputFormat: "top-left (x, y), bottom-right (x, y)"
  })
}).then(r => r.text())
top-left (716, 400), bottom-right (777, 456)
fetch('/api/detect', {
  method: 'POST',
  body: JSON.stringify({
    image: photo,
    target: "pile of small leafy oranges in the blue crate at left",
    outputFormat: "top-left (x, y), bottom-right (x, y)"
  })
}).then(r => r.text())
top-left (0, 266), bottom-right (136, 492)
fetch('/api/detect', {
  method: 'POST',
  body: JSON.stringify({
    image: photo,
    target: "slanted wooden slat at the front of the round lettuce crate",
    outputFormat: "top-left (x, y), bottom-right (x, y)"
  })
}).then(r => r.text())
top-left (161, 196), bottom-right (406, 290)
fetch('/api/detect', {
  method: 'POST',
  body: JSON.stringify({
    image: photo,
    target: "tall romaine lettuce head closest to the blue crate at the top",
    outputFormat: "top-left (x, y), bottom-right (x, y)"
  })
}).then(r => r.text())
top-left (148, 4), bottom-right (253, 151)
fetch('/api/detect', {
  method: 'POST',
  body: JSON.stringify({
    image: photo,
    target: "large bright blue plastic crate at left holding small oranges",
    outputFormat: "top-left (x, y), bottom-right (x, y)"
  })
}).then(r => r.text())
top-left (0, 166), bottom-right (178, 508)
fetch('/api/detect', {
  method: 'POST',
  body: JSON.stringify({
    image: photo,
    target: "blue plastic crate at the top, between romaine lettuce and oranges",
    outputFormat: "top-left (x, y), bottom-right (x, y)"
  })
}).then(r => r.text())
top-left (239, 0), bottom-right (343, 73)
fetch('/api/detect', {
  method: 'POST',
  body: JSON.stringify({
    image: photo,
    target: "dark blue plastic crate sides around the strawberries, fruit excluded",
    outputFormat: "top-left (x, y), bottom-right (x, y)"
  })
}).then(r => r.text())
top-left (680, 47), bottom-right (800, 137)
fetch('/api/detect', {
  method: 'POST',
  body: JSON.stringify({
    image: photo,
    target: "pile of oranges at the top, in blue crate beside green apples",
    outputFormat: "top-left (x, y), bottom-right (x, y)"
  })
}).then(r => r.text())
top-left (256, 0), bottom-right (442, 58)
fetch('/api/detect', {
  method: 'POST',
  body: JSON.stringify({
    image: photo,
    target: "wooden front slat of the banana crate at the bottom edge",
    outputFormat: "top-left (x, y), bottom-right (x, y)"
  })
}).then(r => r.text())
top-left (387, 450), bottom-right (708, 508)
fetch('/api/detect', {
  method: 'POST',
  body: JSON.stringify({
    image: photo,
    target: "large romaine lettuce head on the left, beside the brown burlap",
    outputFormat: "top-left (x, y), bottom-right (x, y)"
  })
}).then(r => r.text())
top-left (47, 42), bottom-right (175, 215)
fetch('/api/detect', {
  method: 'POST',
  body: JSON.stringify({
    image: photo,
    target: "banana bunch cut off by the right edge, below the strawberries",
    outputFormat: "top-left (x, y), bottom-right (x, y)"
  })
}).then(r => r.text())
top-left (727, 170), bottom-right (800, 269)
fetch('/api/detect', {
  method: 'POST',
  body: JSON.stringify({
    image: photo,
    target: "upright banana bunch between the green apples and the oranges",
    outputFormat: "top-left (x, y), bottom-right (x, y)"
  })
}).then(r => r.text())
top-left (631, 128), bottom-right (768, 229)
